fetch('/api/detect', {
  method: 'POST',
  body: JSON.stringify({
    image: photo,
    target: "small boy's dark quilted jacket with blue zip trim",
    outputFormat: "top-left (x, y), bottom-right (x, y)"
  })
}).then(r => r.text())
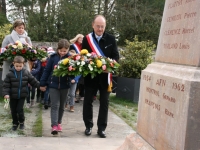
top-left (2, 67), bottom-right (40, 99)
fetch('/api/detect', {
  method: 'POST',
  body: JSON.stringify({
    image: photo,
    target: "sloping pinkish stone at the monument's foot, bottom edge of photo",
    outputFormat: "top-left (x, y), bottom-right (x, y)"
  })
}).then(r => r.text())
top-left (117, 133), bottom-right (155, 150)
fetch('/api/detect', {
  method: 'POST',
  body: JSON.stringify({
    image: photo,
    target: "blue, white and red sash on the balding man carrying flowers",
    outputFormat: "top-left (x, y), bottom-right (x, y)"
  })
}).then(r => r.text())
top-left (86, 33), bottom-right (112, 92)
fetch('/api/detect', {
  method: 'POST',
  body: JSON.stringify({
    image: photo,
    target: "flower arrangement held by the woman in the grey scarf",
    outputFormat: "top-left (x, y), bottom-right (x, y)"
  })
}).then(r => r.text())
top-left (0, 41), bottom-right (47, 64)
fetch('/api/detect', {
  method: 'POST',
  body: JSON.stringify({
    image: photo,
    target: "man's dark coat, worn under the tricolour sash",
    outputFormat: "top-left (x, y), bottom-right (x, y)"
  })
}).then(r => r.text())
top-left (82, 32), bottom-right (119, 88)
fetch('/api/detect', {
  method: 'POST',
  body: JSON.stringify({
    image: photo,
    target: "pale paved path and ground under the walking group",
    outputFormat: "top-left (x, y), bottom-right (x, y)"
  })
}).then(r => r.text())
top-left (0, 96), bottom-right (135, 150)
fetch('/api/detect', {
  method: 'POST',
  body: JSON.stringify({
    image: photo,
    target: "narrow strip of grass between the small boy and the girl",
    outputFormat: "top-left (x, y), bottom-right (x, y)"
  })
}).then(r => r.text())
top-left (32, 104), bottom-right (42, 137)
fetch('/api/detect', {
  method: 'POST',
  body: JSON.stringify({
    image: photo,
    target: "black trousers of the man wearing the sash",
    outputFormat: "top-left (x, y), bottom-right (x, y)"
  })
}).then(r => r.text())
top-left (83, 87), bottom-right (110, 131)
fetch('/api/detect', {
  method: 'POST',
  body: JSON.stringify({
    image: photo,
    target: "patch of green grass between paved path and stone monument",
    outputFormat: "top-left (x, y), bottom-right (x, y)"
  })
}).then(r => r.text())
top-left (109, 95), bottom-right (138, 130)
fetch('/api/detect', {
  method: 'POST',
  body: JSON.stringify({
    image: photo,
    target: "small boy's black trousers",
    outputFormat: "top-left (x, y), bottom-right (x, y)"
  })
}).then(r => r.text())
top-left (10, 98), bottom-right (25, 125)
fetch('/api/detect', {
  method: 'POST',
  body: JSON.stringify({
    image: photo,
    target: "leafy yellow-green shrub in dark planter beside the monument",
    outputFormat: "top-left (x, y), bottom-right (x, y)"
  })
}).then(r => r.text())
top-left (117, 36), bottom-right (156, 79)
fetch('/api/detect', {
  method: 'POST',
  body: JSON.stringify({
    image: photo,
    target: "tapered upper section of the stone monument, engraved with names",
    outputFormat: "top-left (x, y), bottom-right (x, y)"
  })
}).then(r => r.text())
top-left (155, 0), bottom-right (200, 66)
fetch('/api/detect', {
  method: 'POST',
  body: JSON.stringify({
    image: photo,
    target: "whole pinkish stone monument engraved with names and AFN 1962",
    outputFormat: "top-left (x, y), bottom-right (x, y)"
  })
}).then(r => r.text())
top-left (137, 0), bottom-right (200, 150)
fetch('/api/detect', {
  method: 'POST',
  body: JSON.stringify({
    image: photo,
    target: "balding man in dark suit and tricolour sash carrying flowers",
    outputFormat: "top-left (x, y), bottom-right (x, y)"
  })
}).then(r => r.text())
top-left (82, 15), bottom-right (119, 138)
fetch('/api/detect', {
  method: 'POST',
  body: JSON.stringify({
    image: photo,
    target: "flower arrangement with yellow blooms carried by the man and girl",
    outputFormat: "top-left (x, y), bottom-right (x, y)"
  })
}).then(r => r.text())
top-left (53, 49), bottom-right (119, 78)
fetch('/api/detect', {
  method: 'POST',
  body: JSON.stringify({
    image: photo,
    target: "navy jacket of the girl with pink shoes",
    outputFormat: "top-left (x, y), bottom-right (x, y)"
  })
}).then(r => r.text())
top-left (40, 53), bottom-right (71, 89)
